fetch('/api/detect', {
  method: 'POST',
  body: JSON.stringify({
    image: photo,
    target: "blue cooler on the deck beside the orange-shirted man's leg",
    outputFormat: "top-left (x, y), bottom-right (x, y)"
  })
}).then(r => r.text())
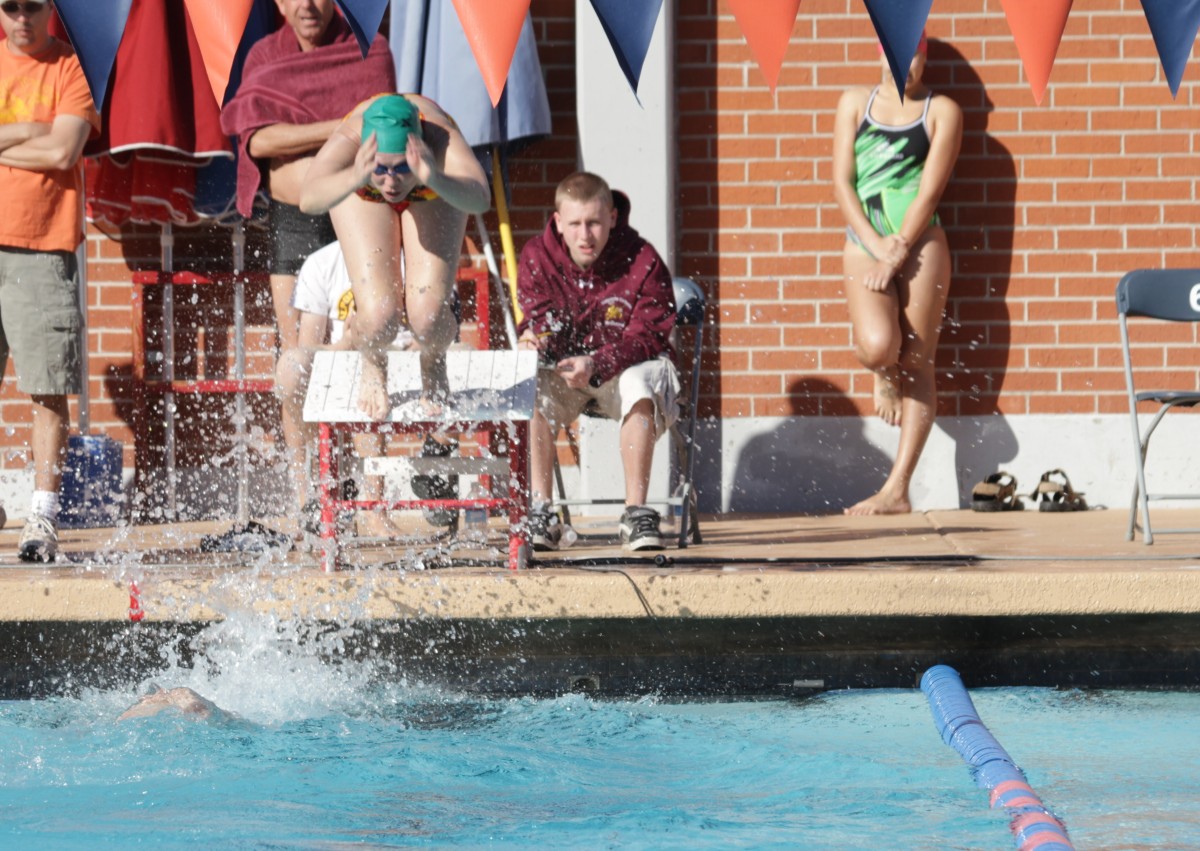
top-left (59, 435), bottom-right (122, 529)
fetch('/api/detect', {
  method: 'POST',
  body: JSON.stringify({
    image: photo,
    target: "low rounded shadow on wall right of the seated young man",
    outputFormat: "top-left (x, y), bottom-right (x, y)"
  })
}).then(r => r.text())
top-left (725, 377), bottom-right (892, 514)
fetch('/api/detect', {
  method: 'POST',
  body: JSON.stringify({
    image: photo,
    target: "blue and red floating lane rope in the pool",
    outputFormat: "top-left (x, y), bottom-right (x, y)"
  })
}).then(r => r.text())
top-left (920, 665), bottom-right (1075, 851)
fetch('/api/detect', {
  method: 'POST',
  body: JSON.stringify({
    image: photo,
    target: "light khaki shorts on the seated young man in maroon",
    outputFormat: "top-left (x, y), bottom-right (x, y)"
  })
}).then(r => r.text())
top-left (538, 355), bottom-right (679, 437)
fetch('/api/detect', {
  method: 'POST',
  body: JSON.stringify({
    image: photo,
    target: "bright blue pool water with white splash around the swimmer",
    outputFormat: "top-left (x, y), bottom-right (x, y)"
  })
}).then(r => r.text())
top-left (0, 619), bottom-right (1200, 850)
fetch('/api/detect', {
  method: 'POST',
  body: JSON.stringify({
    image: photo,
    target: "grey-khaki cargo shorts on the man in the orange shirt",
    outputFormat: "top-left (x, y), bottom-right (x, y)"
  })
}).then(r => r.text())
top-left (0, 247), bottom-right (83, 396)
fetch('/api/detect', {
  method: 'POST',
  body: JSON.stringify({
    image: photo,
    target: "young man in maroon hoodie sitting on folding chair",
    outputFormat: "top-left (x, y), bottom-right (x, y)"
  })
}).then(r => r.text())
top-left (517, 172), bottom-right (679, 550)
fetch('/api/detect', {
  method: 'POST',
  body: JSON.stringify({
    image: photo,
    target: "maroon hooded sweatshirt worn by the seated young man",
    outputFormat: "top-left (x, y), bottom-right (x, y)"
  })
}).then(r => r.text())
top-left (517, 192), bottom-right (674, 386)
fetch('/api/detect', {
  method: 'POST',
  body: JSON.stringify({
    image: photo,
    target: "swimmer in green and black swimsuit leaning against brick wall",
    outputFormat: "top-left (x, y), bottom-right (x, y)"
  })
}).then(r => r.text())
top-left (833, 37), bottom-right (962, 514)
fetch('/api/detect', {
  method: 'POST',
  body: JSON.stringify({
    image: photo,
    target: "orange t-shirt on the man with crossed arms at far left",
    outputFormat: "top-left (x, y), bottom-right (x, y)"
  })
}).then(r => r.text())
top-left (0, 40), bottom-right (100, 251)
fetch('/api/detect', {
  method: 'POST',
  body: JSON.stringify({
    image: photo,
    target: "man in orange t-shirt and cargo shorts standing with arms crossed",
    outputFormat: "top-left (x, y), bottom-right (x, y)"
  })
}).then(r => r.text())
top-left (0, 0), bottom-right (100, 562)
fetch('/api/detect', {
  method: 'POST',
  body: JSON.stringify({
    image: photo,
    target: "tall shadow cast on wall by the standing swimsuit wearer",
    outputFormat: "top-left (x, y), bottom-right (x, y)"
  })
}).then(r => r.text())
top-left (925, 41), bottom-right (1026, 508)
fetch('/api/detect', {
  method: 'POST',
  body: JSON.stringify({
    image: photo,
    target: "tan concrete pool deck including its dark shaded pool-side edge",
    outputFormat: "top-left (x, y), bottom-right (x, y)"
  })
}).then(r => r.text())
top-left (0, 509), bottom-right (1200, 696)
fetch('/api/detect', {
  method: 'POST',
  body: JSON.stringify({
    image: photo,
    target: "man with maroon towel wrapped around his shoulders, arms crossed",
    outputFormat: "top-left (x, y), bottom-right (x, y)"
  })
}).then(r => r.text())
top-left (221, 0), bottom-right (396, 484)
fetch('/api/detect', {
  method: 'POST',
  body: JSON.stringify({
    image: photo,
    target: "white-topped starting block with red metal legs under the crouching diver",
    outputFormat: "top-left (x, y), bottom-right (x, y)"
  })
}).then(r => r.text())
top-left (304, 350), bottom-right (538, 570)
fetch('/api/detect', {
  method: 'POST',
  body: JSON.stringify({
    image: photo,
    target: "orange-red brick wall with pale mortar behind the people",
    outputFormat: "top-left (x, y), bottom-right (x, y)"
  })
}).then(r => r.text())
top-left (0, 0), bottom-right (1200, 496)
